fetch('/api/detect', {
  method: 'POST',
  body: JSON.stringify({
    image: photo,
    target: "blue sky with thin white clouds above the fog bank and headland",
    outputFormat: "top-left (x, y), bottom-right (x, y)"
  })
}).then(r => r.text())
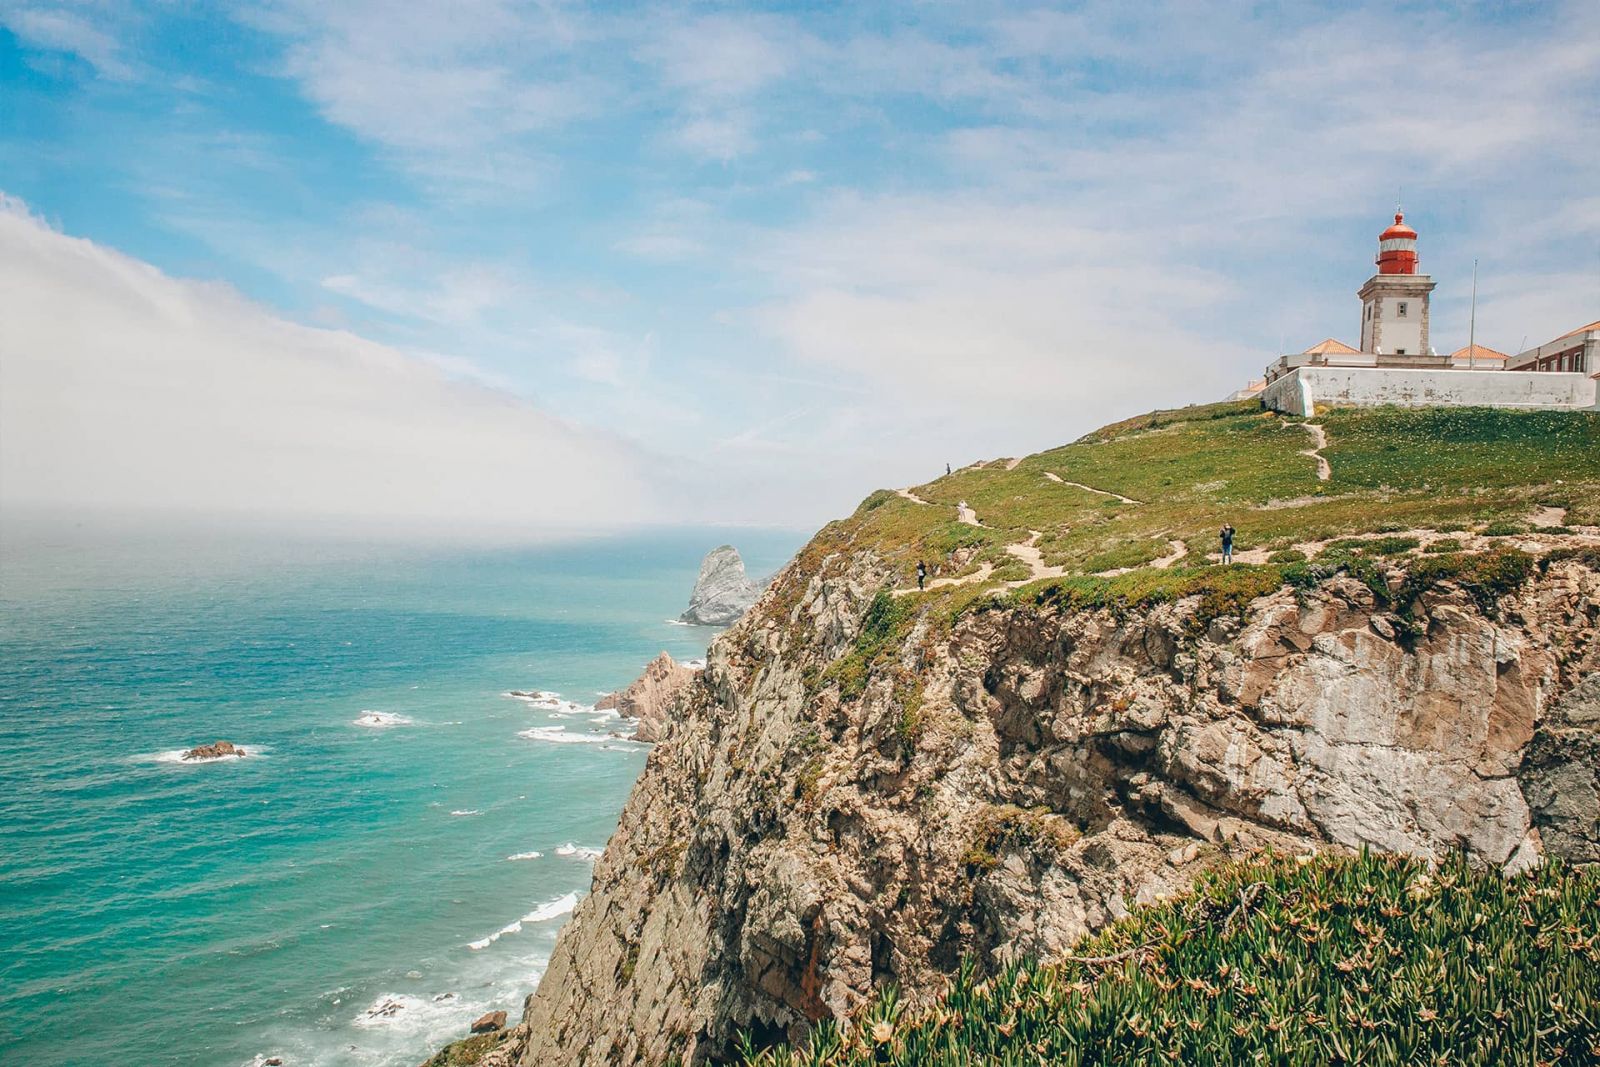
top-left (0, 0), bottom-right (1600, 523)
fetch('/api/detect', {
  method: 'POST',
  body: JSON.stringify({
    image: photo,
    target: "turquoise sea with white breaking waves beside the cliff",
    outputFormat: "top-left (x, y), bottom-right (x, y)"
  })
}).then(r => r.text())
top-left (0, 528), bottom-right (802, 1067)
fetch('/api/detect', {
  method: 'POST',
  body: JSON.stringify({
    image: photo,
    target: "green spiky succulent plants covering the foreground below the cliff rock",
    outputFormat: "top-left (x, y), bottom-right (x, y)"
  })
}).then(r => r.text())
top-left (744, 856), bottom-right (1600, 1067)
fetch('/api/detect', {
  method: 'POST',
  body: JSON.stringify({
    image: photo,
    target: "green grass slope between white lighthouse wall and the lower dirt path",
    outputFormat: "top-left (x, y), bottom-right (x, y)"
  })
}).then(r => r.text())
top-left (800, 402), bottom-right (1600, 584)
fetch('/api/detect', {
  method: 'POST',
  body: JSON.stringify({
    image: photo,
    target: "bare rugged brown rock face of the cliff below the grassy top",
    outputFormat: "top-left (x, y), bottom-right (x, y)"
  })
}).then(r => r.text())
top-left (518, 550), bottom-right (1600, 1067)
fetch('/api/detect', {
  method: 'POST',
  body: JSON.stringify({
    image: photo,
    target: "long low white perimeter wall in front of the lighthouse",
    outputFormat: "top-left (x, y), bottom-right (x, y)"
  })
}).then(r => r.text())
top-left (1261, 366), bottom-right (1595, 414)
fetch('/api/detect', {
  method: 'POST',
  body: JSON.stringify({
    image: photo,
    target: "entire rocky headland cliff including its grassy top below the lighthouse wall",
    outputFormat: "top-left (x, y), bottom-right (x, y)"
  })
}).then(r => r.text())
top-left (448, 405), bottom-right (1600, 1067)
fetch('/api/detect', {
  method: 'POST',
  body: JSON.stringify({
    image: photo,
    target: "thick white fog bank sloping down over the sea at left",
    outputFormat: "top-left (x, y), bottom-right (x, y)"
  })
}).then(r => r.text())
top-left (0, 200), bottom-right (654, 533)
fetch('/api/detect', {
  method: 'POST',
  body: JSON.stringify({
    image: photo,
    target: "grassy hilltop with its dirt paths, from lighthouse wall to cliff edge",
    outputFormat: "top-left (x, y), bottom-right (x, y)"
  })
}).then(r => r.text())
top-left (789, 402), bottom-right (1600, 633)
